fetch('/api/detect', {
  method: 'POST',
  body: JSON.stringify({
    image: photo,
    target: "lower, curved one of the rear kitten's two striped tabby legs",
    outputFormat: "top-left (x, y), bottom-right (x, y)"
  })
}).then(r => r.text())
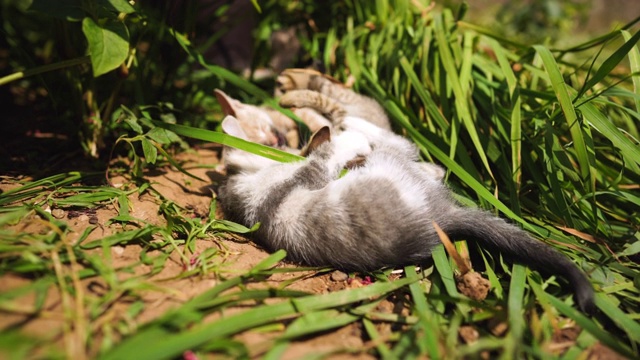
top-left (279, 90), bottom-right (347, 124)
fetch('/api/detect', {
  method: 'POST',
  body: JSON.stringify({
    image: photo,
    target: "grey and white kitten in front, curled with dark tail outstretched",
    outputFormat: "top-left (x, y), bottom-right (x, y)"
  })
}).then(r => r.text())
top-left (218, 116), bottom-right (594, 312)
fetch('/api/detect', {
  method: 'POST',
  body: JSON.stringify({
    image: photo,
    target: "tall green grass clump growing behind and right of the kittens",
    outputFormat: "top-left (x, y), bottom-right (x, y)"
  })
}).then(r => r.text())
top-left (296, 1), bottom-right (640, 355)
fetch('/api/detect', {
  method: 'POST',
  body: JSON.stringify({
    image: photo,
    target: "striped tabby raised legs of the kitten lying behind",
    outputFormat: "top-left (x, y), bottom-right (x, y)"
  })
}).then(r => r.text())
top-left (275, 69), bottom-right (391, 131)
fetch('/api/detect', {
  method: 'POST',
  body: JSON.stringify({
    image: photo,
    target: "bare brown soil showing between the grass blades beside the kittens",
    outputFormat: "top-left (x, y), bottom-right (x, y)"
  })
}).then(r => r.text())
top-left (0, 147), bottom-right (388, 359)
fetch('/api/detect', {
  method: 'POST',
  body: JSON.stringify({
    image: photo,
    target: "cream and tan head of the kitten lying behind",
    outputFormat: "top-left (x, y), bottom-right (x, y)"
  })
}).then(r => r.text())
top-left (215, 89), bottom-right (285, 146)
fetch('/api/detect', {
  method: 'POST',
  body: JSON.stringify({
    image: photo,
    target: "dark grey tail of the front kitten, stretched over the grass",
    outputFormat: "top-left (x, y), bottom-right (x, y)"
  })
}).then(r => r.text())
top-left (438, 209), bottom-right (595, 314)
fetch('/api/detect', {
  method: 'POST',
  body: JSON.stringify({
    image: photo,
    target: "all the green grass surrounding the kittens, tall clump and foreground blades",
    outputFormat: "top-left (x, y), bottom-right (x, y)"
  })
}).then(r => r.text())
top-left (0, 0), bottom-right (640, 359)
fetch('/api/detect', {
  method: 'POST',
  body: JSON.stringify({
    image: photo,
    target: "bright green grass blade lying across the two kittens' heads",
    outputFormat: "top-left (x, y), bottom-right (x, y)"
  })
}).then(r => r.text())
top-left (153, 121), bottom-right (304, 162)
